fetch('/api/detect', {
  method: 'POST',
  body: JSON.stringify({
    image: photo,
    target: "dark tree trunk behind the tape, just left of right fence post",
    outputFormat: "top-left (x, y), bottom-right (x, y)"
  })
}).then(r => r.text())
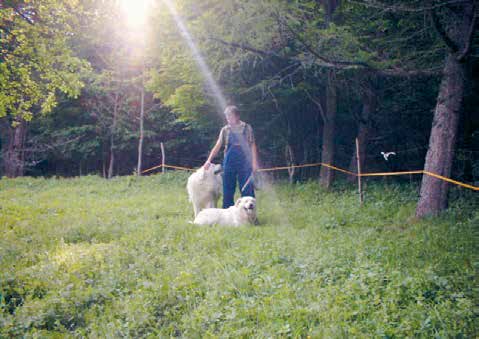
top-left (319, 71), bottom-right (337, 188)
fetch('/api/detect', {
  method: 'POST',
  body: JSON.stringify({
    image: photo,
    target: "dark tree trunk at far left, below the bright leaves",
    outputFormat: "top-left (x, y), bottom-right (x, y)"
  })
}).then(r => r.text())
top-left (3, 120), bottom-right (27, 178)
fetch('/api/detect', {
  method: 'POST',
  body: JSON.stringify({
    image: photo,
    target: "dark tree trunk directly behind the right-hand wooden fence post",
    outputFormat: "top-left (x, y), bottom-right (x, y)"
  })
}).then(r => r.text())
top-left (348, 88), bottom-right (376, 182)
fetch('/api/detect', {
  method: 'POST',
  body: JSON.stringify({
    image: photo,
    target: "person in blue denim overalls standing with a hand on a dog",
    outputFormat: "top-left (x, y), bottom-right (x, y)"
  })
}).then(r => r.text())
top-left (204, 106), bottom-right (258, 208)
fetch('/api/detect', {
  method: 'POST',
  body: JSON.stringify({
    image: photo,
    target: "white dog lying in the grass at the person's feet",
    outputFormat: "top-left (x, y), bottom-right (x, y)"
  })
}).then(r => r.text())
top-left (194, 197), bottom-right (256, 226)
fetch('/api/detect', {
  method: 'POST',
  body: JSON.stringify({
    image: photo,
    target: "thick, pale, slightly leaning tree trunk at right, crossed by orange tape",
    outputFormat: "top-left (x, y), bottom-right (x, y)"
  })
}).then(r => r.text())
top-left (416, 54), bottom-right (465, 217)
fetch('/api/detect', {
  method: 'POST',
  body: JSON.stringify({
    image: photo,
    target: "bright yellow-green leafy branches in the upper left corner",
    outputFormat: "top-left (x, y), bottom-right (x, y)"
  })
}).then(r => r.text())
top-left (0, 1), bottom-right (89, 121)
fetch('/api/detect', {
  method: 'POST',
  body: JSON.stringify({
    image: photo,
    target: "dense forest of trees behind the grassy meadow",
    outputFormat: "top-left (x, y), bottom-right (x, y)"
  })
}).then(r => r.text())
top-left (0, 0), bottom-right (479, 216)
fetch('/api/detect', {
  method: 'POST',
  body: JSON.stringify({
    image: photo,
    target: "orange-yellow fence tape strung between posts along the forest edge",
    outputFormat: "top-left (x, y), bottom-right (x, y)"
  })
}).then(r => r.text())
top-left (142, 162), bottom-right (479, 191)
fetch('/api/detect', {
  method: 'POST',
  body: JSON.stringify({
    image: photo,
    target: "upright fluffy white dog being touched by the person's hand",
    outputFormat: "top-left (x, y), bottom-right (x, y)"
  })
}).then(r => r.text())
top-left (186, 164), bottom-right (223, 217)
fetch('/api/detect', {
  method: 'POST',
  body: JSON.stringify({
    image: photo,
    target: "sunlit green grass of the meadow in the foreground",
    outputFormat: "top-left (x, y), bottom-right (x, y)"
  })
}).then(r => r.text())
top-left (0, 173), bottom-right (479, 338)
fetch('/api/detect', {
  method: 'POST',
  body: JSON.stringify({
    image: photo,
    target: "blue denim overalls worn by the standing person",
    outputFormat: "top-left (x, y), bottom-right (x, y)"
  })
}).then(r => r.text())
top-left (223, 128), bottom-right (254, 208)
